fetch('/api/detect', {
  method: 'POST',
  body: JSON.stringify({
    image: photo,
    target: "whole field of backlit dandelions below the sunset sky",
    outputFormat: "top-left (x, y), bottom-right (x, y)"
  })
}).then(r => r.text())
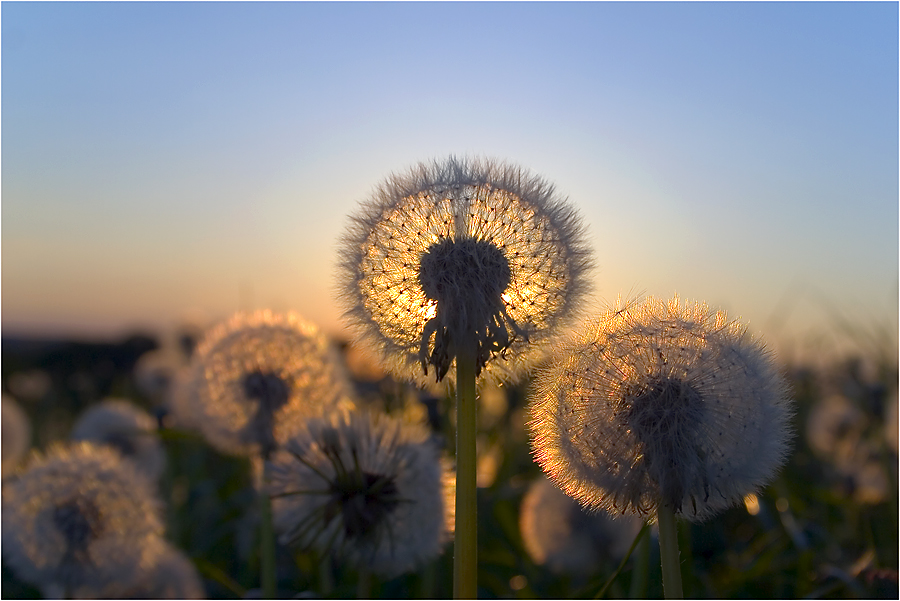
top-left (2, 156), bottom-right (898, 598)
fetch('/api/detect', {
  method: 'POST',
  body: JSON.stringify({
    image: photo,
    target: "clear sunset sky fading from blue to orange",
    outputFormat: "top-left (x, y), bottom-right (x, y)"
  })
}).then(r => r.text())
top-left (0, 2), bottom-right (900, 360)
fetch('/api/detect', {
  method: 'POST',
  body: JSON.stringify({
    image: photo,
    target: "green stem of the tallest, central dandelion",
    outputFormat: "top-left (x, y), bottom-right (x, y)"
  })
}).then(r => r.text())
top-left (453, 344), bottom-right (478, 599)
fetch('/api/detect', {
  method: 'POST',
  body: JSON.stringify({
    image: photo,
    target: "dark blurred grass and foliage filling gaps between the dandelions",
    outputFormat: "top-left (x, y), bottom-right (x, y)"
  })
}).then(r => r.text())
top-left (2, 328), bottom-right (898, 599)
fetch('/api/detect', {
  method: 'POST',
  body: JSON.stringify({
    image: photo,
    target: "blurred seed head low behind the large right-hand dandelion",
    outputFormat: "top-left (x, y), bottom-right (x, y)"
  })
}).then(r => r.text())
top-left (519, 477), bottom-right (642, 576)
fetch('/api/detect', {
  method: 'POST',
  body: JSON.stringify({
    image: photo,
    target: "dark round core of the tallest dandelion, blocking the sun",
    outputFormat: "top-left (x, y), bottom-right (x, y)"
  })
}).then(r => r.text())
top-left (419, 238), bottom-right (512, 304)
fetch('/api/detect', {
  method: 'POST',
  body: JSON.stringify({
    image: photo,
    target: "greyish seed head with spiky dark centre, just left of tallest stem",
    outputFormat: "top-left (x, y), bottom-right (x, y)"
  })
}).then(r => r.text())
top-left (268, 413), bottom-right (455, 577)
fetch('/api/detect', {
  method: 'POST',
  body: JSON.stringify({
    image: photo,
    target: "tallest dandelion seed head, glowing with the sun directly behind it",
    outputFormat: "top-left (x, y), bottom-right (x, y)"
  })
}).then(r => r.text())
top-left (339, 157), bottom-right (590, 383)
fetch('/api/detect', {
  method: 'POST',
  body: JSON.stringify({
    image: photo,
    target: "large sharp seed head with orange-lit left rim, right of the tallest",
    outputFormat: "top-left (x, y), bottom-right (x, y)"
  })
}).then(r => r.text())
top-left (529, 297), bottom-right (792, 520)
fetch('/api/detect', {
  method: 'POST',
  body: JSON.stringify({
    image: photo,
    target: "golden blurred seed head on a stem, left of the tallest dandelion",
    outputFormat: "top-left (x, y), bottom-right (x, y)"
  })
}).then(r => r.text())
top-left (188, 311), bottom-right (352, 456)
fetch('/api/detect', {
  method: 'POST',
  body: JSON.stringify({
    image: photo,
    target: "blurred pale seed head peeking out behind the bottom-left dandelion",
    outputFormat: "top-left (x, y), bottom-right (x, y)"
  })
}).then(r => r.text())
top-left (70, 399), bottom-right (166, 480)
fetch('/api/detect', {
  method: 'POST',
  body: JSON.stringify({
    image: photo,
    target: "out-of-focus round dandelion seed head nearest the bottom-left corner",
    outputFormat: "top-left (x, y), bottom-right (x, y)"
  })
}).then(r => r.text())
top-left (2, 442), bottom-right (163, 590)
